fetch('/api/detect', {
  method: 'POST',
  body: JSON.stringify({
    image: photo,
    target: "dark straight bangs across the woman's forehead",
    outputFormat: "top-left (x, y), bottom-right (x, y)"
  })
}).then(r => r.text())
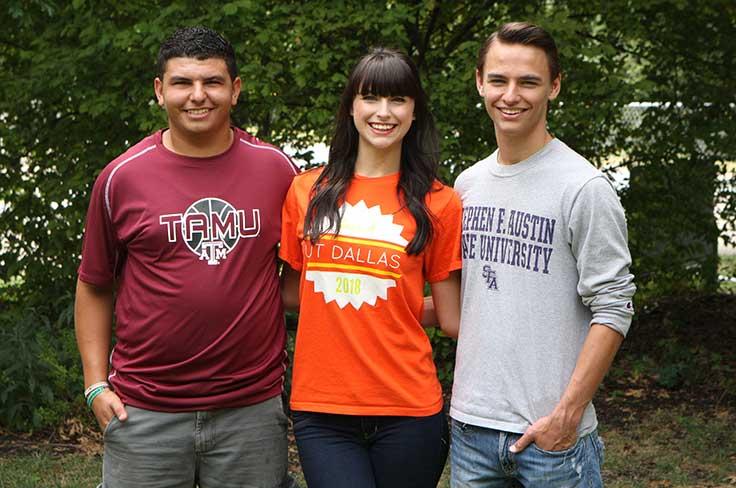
top-left (350, 49), bottom-right (421, 99)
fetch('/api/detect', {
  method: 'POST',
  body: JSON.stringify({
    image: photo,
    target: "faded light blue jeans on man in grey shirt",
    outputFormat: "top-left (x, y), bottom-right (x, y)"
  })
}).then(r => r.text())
top-left (450, 419), bottom-right (603, 488)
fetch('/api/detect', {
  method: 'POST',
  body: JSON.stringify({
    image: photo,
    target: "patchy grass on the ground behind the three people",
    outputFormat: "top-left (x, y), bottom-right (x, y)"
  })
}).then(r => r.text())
top-left (0, 407), bottom-right (736, 488)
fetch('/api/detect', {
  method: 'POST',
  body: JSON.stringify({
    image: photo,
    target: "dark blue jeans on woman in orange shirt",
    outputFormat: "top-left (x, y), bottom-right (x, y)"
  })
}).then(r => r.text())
top-left (292, 412), bottom-right (449, 488)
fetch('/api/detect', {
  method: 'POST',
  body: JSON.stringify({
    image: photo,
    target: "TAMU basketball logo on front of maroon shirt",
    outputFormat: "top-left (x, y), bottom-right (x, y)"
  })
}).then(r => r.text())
top-left (159, 198), bottom-right (261, 266)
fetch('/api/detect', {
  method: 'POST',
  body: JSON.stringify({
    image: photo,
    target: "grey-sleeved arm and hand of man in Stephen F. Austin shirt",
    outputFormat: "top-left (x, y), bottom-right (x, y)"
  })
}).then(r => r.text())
top-left (512, 178), bottom-right (636, 452)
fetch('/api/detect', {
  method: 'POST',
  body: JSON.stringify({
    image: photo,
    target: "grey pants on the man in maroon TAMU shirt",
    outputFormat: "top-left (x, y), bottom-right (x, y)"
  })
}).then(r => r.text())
top-left (102, 396), bottom-right (291, 488)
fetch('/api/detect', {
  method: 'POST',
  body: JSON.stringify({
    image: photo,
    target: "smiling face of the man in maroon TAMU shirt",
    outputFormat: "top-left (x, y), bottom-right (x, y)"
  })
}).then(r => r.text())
top-left (154, 58), bottom-right (240, 139)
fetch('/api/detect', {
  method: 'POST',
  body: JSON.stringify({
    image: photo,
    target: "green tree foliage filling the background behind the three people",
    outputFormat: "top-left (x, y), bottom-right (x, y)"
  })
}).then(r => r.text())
top-left (0, 0), bottom-right (736, 428)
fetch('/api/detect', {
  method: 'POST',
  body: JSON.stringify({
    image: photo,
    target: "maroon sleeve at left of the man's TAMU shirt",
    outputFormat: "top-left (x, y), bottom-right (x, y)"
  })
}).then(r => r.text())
top-left (78, 168), bottom-right (124, 286)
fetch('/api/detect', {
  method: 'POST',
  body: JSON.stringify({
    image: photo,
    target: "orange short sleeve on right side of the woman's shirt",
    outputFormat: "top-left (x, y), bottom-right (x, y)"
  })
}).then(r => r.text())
top-left (424, 187), bottom-right (463, 283)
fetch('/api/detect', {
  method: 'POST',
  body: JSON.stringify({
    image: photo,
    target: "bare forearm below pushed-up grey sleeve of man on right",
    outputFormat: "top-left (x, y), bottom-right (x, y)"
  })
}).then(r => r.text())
top-left (553, 324), bottom-right (624, 427)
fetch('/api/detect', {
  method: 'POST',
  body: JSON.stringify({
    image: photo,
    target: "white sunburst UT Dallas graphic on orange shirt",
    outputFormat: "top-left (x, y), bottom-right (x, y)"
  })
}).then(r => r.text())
top-left (305, 200), bottom-right (408, 310)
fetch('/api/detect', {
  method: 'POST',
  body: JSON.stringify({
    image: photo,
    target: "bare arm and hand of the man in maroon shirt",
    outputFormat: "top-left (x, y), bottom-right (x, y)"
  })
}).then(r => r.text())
top-left (74, 279), bottom-right (128, 430)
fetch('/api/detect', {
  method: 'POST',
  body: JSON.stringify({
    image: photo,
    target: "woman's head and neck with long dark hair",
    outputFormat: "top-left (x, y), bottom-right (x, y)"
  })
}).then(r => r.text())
top-left (306, 49), bottom-right (439, 252)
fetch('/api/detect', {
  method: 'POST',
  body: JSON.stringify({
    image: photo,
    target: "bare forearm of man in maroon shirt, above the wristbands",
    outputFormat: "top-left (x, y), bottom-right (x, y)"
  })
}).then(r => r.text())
top-left (74, 280), bottom-right (113, 386)
